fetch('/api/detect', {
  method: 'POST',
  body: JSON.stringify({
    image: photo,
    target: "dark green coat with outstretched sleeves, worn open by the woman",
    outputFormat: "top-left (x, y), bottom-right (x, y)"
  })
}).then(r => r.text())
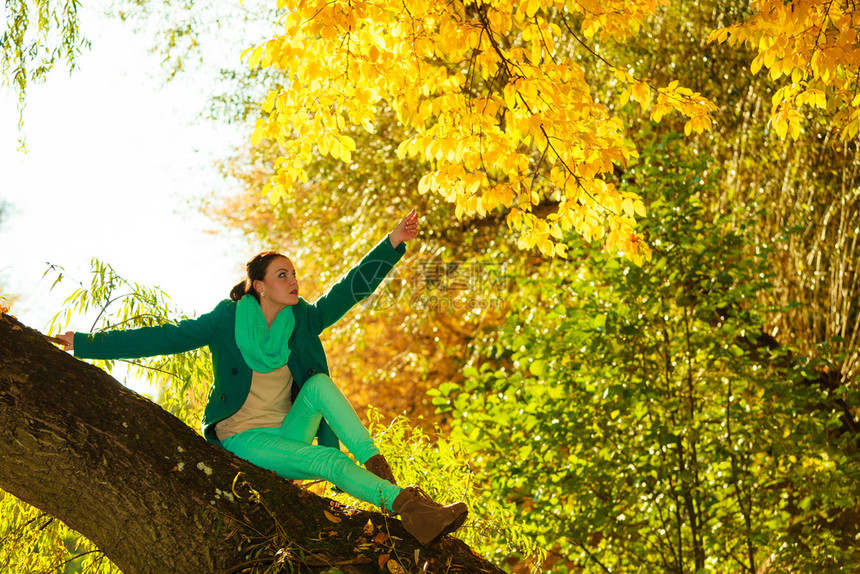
top-left (74, 236), bottom-right (406, 448)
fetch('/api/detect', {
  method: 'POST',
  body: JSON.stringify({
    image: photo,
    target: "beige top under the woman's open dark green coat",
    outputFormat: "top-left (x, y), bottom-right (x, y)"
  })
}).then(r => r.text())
top-left (215, 365), bottom-right (293, 440)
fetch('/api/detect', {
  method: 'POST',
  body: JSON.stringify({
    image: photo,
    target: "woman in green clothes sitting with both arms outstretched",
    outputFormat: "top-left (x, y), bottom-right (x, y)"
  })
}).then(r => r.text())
top-left (58, 210), bottom-right (467, 545)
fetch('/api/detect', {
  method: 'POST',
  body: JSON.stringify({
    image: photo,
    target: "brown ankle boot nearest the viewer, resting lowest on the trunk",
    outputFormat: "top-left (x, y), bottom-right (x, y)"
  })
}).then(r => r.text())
top-left (392, 486), bottom-right (469, 546)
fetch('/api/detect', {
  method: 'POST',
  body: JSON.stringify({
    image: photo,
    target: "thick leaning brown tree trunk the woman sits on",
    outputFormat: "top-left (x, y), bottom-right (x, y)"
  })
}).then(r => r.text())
top-left (0, 314), bottom-right (502, 574)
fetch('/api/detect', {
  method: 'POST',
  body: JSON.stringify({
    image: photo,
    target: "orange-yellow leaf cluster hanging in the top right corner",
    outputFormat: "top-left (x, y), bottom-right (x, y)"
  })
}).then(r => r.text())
top-left (710, 0), bottom-right (860, 140)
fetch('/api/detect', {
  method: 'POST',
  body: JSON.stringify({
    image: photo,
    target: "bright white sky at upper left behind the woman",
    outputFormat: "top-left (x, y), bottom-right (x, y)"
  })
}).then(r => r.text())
top-left (0, 3), bottom-right (268, 388)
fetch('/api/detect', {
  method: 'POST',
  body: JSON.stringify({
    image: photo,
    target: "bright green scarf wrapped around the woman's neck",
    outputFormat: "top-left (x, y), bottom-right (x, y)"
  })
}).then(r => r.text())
top-left (236, 295), bottom-right (296, 373)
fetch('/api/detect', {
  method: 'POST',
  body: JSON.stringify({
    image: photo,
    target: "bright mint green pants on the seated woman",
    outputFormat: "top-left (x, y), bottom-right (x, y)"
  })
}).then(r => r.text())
top-left (221, 374), bottom-right (401, 510)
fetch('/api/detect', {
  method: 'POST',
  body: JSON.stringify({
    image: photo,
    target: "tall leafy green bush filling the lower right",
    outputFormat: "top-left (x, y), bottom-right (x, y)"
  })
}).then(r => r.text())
top-left (435, 141), bottom-right (860, 573)
